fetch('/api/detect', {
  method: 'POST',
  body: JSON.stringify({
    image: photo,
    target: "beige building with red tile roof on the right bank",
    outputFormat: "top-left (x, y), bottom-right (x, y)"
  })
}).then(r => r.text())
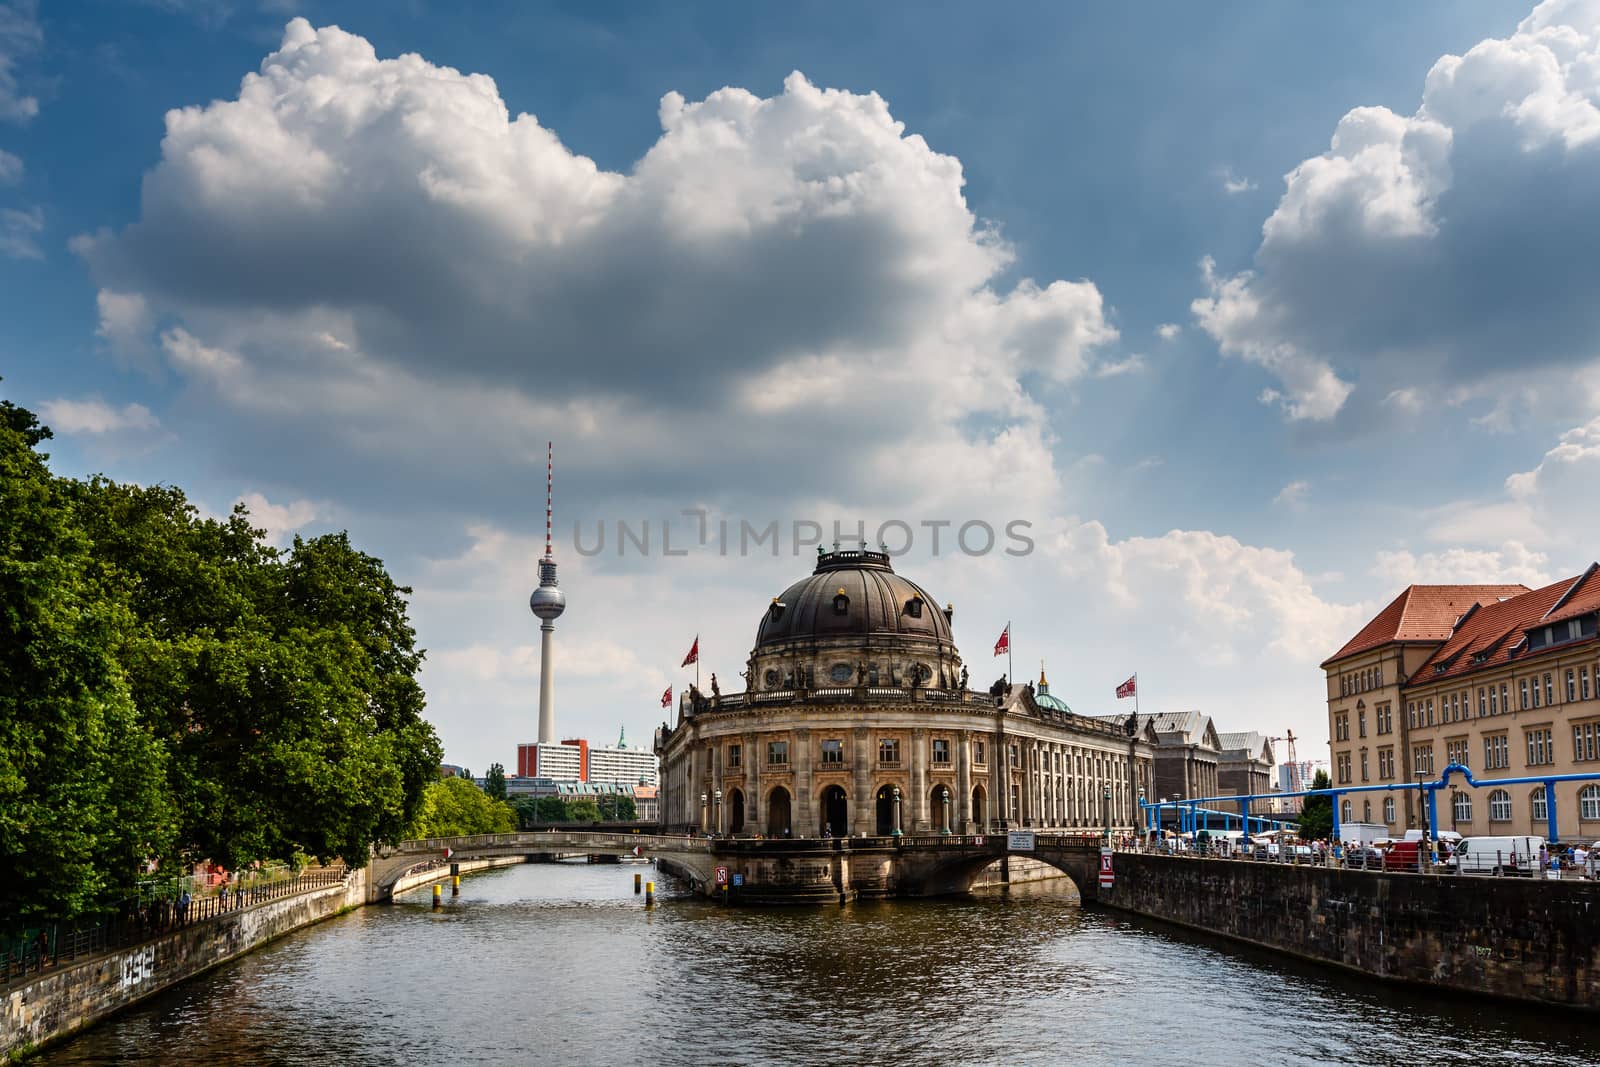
top-left (1323, 565), bottom-right (1600, 840)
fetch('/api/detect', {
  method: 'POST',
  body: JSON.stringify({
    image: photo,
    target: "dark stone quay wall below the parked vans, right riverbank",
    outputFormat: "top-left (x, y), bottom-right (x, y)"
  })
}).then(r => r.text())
top-left (1099, 853), bottom-right (1600, 1011)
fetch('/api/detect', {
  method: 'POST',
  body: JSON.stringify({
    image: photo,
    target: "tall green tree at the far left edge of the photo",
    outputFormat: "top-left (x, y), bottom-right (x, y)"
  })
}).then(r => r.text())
top-left (0, 402), bottom-right (176, 923)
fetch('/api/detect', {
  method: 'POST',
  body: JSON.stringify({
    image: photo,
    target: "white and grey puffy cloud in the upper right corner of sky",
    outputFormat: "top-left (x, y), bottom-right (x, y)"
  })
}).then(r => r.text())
top-left (1194, 0), bottom-right (1600, 421)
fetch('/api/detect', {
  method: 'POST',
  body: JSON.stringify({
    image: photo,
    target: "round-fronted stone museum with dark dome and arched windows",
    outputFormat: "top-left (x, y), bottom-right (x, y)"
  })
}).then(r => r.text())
top-left (656, 549), bottom-right (1155, 838)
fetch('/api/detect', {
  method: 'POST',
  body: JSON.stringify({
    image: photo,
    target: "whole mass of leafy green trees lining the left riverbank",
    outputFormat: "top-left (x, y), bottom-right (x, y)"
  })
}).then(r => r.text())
top-left (0, 391), bottom-right (442, 918)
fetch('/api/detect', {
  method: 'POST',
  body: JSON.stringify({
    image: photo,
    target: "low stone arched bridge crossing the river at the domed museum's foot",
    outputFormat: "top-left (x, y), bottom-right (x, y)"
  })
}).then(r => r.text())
top-left (370, 830), bottom-right (1101, 904)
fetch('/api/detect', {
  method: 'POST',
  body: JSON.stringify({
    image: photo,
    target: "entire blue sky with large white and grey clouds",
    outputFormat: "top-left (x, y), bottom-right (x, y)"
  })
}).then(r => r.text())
top-left (0, 0), bottom-right (1600, 773)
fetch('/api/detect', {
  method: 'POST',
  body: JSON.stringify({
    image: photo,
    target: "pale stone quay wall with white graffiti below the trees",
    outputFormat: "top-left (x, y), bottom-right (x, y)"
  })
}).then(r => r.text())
top-left (0, 870), bottom-right (366, 1064)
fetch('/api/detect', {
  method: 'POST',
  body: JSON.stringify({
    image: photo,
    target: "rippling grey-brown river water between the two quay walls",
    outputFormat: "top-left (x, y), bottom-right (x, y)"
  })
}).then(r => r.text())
top-left (37, 864), bottom-right (1600, 1067)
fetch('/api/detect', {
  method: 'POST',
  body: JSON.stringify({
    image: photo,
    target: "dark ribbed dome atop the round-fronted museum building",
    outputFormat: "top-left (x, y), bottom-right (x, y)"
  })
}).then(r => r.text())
top-left (755, 549), bottom-right (954, 651)
